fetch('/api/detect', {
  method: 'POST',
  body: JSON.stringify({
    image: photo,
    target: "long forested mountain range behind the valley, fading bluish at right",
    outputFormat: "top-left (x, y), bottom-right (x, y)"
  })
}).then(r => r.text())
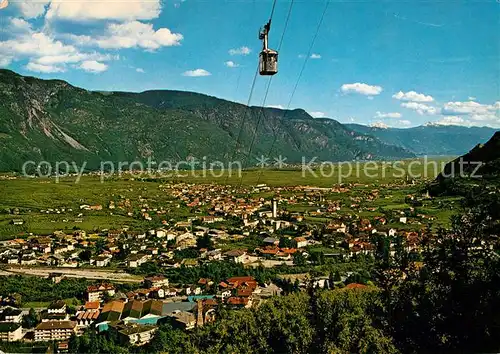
top-left (0, 70), bottom-right (494, 171)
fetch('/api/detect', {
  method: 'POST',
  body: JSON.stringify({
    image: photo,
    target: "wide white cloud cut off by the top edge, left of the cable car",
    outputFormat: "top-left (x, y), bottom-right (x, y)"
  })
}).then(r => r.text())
top-left (46, 0), bottom-right (161, 21)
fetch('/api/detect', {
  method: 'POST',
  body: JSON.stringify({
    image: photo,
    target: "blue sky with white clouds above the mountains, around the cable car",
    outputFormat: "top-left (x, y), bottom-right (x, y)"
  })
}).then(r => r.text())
top-left (0, 0), bottom-right (500, 128)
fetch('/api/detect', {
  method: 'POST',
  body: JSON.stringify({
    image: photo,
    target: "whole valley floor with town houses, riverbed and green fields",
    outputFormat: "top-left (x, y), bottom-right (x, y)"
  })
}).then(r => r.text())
top-left (0, 167), bottom-right (484, 352)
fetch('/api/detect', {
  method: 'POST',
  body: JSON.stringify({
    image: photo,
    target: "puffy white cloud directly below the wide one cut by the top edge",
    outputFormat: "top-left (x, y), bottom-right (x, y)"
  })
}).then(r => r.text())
top-left (72, 21), bottom-right (184, 51)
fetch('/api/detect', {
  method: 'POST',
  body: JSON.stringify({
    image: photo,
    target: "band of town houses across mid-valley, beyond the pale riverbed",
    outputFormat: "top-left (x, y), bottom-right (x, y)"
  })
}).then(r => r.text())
top-left (0, 183), bottom-right (438, 268)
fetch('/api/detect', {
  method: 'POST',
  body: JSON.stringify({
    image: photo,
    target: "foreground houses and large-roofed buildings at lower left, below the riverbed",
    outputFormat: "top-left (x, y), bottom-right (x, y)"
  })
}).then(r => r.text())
top-left (0, 275), bottom-right (282, 348)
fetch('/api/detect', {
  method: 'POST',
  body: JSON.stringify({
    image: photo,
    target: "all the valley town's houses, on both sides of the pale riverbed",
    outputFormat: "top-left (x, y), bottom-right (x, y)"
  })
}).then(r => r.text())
top-left (0, 183), bottom-right (478, 349)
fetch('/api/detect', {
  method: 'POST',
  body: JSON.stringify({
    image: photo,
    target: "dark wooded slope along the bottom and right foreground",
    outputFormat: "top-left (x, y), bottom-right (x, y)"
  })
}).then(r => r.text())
top-left (70, 194), bottom-right (500, 353)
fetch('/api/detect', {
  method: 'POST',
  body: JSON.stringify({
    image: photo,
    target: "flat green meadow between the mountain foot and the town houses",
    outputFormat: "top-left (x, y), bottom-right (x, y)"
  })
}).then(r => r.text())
top-left (0, 158), bottom-right (454, 239)
